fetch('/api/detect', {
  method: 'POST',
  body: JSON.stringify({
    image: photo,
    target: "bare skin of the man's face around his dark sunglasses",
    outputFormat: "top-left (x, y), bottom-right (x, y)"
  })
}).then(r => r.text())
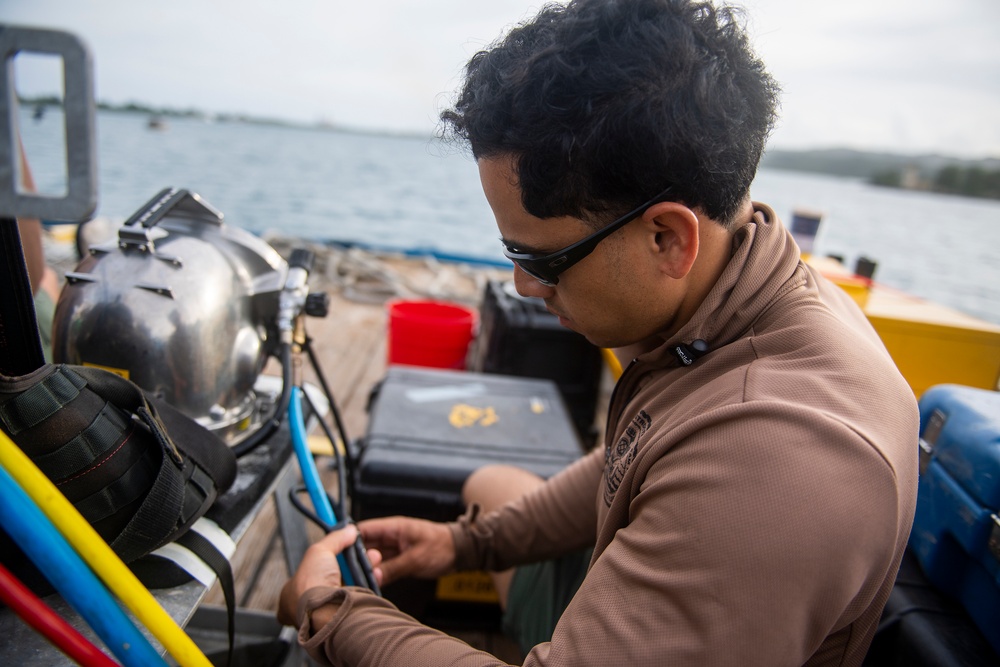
top-left (479, 157), bottom-right (669, 347)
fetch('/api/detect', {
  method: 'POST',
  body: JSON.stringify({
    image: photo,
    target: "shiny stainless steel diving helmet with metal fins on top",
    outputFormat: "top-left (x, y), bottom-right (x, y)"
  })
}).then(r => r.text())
top-left (53, 189), bottom-right (288, 443)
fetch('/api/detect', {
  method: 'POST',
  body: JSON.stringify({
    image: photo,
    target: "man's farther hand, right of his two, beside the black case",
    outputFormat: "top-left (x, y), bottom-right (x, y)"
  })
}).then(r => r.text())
top-left (358, 516), bottom-right (455, 585)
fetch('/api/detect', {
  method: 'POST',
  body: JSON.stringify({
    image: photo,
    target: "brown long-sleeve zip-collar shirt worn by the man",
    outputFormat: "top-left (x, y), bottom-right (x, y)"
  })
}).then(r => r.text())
top-left (303, 205), bottom-right (918, 667)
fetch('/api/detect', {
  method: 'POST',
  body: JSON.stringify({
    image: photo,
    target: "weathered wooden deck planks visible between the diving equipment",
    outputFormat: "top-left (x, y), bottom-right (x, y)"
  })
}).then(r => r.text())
top-left (194, 244), bottom-right (520, 662)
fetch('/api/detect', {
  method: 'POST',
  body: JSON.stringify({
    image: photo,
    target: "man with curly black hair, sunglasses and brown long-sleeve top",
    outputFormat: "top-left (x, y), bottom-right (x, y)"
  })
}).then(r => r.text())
top-left (279, 0), bottom-right (918, 666)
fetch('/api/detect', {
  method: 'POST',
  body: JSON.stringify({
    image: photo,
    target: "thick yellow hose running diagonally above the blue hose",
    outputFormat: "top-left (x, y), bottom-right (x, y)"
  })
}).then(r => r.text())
top-left (0, 431), bottom-right (212, 667)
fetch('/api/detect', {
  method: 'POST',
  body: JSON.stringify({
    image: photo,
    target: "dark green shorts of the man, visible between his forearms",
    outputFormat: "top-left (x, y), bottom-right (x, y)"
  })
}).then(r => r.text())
top-left (503, 548), bottom-right (594, 655)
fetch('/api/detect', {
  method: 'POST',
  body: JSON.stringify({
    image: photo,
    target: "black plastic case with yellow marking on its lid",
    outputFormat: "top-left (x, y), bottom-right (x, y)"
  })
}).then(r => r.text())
top-left (352, 366), bottom-right (581, 521)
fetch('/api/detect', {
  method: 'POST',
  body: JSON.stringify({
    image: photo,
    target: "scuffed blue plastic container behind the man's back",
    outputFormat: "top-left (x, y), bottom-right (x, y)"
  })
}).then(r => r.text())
top-left (910, 385), bottom-right (1000, 653)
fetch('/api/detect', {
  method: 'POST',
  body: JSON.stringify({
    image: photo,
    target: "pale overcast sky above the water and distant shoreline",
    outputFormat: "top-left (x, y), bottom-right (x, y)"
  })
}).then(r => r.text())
top-left (0, 0), bottom-right (1000, 157)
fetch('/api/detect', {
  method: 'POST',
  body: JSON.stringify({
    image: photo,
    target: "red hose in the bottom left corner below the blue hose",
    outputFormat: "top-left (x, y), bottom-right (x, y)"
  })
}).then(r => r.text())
top-left (0, 564), bottom-right (119, 667)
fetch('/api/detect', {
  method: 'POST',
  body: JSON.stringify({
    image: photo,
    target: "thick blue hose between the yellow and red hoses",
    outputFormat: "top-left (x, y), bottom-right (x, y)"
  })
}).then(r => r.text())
top-left (0, 467), bottom-right (167, 667)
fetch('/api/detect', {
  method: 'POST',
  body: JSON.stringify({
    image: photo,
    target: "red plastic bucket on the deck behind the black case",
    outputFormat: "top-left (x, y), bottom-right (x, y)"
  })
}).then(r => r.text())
top-left (388, 301), bottom-right (478, 369)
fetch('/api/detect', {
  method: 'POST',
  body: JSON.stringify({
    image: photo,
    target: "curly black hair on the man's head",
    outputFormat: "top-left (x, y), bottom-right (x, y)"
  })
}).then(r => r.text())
top-left (441, 0), bottom-right (779, 225)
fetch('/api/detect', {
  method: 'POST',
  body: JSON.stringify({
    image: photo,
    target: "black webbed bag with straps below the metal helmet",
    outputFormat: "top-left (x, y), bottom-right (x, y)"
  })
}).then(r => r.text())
top-left (0, 364), bottom-right (236, 594)
